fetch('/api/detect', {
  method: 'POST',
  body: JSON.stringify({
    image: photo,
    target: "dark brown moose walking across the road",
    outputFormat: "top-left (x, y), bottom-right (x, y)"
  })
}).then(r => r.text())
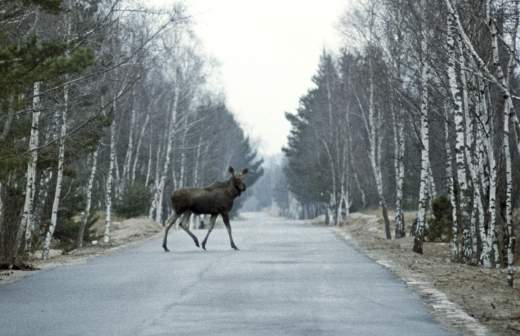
top-left (163, 167), bottom-right (248, 252)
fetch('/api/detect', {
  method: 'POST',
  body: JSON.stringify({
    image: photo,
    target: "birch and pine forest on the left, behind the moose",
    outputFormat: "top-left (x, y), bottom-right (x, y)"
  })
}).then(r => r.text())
top-left (0, 0), bottom-right (263, 269)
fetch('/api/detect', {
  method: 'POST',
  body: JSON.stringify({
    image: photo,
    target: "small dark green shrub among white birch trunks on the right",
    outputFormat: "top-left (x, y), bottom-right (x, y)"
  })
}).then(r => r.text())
top-left (425, 195), bottom-right (453, 242)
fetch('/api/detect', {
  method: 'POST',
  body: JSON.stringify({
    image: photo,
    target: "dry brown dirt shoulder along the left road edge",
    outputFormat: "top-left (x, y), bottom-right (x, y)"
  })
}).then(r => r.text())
top-left (0, 217), bottom-right (163, 286)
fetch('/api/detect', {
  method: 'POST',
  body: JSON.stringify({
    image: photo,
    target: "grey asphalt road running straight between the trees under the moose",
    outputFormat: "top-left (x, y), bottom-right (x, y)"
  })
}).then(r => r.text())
top-left (0, 214), bottom-right (451, 336)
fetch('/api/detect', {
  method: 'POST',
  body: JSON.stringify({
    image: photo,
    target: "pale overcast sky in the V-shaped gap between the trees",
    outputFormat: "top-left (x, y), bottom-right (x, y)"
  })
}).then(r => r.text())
top-left (143, 0), bottom-right (349, 155)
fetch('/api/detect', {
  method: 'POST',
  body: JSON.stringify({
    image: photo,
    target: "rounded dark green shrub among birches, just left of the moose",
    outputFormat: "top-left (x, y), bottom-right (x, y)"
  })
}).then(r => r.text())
top-left (114, 182), bottom-right (152, 218)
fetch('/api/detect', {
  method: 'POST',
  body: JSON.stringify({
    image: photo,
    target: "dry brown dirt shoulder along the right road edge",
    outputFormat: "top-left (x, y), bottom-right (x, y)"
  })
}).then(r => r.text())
top-left (337, 213), bottom-right (520, 336)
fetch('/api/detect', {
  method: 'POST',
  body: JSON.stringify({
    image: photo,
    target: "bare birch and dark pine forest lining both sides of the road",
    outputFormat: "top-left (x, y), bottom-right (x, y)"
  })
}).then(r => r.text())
top-left (0, 0), bottom-right (520, 292)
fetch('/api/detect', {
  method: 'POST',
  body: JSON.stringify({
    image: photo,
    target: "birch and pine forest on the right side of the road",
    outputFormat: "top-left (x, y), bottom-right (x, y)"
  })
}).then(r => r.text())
top-left (283, 0), bottom-right (520, 286)
